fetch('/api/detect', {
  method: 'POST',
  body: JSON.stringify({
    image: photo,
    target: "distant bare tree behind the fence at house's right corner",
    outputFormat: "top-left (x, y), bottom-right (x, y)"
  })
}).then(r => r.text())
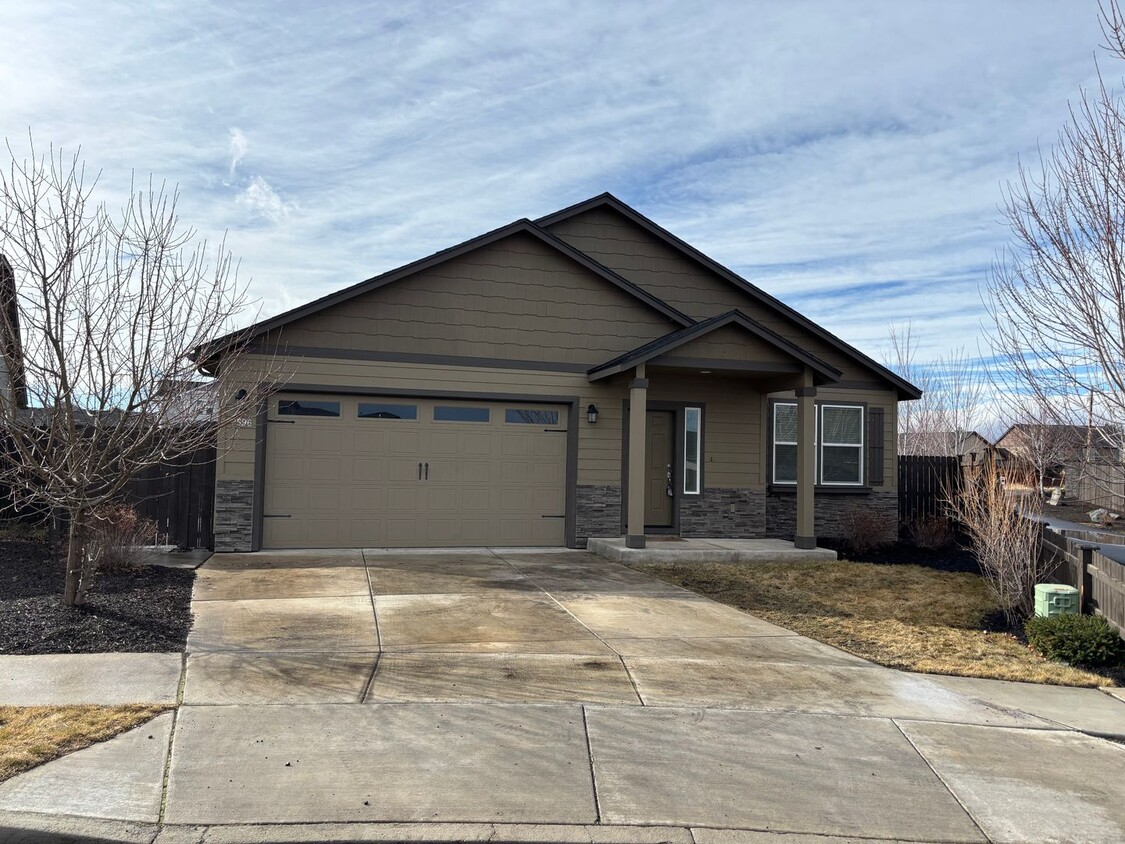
top-left (884, 323), bottom-right (988, 456)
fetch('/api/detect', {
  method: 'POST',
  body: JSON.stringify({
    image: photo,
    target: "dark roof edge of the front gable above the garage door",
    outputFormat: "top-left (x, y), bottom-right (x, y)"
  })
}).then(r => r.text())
top-left (192, 219), bottom-right (694, 362)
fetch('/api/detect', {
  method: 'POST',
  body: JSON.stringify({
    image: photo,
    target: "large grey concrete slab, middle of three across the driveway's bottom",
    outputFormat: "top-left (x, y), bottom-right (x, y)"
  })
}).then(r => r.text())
top-left (586, 707), bottom-right (984, 842)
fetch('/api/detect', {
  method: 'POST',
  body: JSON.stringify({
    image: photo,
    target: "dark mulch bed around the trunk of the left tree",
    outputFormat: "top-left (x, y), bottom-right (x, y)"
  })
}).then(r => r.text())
top-left (0, 540), bottom-right (195, 654)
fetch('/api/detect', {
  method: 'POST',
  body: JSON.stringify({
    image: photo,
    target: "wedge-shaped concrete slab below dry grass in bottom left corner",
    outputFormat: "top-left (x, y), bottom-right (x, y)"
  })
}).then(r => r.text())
top-left (0, 712), bottom-right (172, 823)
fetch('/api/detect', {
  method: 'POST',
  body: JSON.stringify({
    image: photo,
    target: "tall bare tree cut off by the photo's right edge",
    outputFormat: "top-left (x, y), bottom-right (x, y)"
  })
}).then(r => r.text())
top-left (988, 0), bottom-right (1125, 499)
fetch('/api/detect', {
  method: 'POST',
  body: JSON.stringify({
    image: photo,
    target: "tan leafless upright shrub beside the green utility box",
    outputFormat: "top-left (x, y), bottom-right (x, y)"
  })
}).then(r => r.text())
top-left (948, 458), bottom-right (1044, 625)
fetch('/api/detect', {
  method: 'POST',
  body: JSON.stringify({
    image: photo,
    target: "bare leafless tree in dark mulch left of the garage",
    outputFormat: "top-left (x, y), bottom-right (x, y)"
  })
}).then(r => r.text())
top-left (0, 144), bottom-right (270, 605)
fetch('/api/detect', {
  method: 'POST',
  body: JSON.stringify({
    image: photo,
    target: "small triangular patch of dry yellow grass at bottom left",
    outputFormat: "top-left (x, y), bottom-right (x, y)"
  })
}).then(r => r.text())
top-left (0, 704), bottom-right (168, 782)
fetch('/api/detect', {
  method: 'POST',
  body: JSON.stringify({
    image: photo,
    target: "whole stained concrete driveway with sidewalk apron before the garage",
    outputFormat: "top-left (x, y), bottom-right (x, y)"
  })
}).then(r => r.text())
top-left (0, 550), bottom-right (1125, 844)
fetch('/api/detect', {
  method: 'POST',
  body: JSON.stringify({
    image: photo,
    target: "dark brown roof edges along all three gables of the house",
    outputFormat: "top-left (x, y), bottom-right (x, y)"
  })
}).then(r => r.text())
top-left (192, 194), bottom-right (921, 398)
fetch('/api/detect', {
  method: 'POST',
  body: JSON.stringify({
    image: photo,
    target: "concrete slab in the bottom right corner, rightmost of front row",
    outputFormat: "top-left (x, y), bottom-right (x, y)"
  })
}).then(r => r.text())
top-left (899, 721), bottom-right (1125, 844)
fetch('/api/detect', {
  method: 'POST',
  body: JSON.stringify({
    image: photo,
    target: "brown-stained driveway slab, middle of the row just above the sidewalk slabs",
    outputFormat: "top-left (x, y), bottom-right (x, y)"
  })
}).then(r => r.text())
top-left (367, 654), bottom-right (640, 706)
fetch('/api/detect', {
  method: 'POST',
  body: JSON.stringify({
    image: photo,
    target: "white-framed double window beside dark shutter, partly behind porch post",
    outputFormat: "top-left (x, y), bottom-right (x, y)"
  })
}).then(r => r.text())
top-left (771, 402), bottom-right (865, 486)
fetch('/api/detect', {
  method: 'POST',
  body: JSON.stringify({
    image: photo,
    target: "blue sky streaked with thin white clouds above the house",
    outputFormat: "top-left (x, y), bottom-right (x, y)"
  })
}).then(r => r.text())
top-left (0, 0), bottom-right (1107, 369)
